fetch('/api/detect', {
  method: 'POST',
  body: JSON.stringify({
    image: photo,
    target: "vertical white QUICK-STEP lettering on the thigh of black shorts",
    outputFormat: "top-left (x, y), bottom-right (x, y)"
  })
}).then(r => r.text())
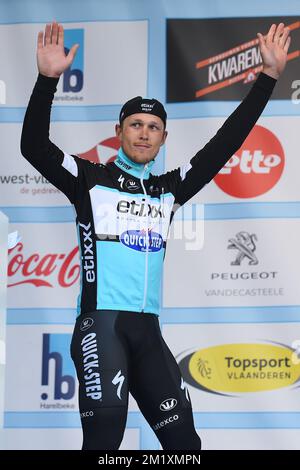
top-left (81, 333), bottom-right (102, 400)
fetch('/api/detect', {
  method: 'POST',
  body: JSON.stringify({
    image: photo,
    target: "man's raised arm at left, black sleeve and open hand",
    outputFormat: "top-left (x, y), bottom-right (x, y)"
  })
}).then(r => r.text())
top-left (21, 21), bottom-right (84, 203)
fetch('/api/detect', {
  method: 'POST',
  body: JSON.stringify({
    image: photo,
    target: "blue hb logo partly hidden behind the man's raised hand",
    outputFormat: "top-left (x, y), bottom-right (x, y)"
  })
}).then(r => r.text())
top-left (63, 29), bottom-right (84, 93)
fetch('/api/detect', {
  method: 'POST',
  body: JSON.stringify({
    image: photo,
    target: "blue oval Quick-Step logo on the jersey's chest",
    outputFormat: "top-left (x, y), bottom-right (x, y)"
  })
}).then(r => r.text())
top-left (120, 230), bottom-right (163, 252)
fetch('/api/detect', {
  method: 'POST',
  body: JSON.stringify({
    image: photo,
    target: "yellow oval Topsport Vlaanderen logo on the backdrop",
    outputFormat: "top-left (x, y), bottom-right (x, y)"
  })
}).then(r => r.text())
top-left (186, 343), bottom-right (300, 393)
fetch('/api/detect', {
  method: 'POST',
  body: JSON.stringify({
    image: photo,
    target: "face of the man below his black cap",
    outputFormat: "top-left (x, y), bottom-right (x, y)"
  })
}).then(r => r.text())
top-left (116, 113), bottom-right (168, 163)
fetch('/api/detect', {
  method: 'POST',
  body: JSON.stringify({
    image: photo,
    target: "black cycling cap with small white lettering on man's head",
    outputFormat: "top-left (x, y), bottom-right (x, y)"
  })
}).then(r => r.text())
top-left (119, 96), bottom-right (167, 126)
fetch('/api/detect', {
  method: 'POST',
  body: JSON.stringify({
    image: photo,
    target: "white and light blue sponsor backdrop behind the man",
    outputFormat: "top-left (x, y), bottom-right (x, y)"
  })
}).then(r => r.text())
top-left (0, 0), bottom-right (300, 449)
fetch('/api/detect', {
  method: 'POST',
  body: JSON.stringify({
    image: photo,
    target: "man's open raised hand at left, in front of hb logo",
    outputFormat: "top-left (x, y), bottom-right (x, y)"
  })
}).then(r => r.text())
top-left (37, 21), bottom-right (79, 78)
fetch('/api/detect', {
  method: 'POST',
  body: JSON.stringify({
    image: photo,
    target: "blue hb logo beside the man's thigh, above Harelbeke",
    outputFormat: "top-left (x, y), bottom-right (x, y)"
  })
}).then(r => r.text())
top-left (41, 333), bottom-right (75, 400)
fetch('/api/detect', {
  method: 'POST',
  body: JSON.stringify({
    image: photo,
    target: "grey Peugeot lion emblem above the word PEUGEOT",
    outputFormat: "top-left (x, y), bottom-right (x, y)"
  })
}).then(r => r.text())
top-left (227, 232), bottom-right (258, 266)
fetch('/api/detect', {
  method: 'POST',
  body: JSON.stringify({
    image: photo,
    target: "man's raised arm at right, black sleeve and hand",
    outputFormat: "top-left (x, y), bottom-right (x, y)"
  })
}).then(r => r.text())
top-left (171, 23), bottom-right (290, 205)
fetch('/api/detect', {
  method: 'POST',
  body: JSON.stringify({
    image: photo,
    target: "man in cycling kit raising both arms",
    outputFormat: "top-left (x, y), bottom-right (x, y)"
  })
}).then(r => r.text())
top-left (21, 22), bottom-right (290, 450)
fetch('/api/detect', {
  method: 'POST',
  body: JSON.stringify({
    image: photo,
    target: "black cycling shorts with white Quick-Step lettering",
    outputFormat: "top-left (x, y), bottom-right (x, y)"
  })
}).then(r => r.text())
top-left (71, 310), bottom-right (201, 450)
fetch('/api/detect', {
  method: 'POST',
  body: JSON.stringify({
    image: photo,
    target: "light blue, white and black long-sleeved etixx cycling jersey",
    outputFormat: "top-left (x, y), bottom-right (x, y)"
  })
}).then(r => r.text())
top-left (21, 73), bottom-right (276, 315)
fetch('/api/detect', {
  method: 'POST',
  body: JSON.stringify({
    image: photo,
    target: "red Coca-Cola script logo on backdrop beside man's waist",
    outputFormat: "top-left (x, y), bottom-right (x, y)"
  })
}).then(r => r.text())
top-left (7, 243), bottom-right (80, 287)
